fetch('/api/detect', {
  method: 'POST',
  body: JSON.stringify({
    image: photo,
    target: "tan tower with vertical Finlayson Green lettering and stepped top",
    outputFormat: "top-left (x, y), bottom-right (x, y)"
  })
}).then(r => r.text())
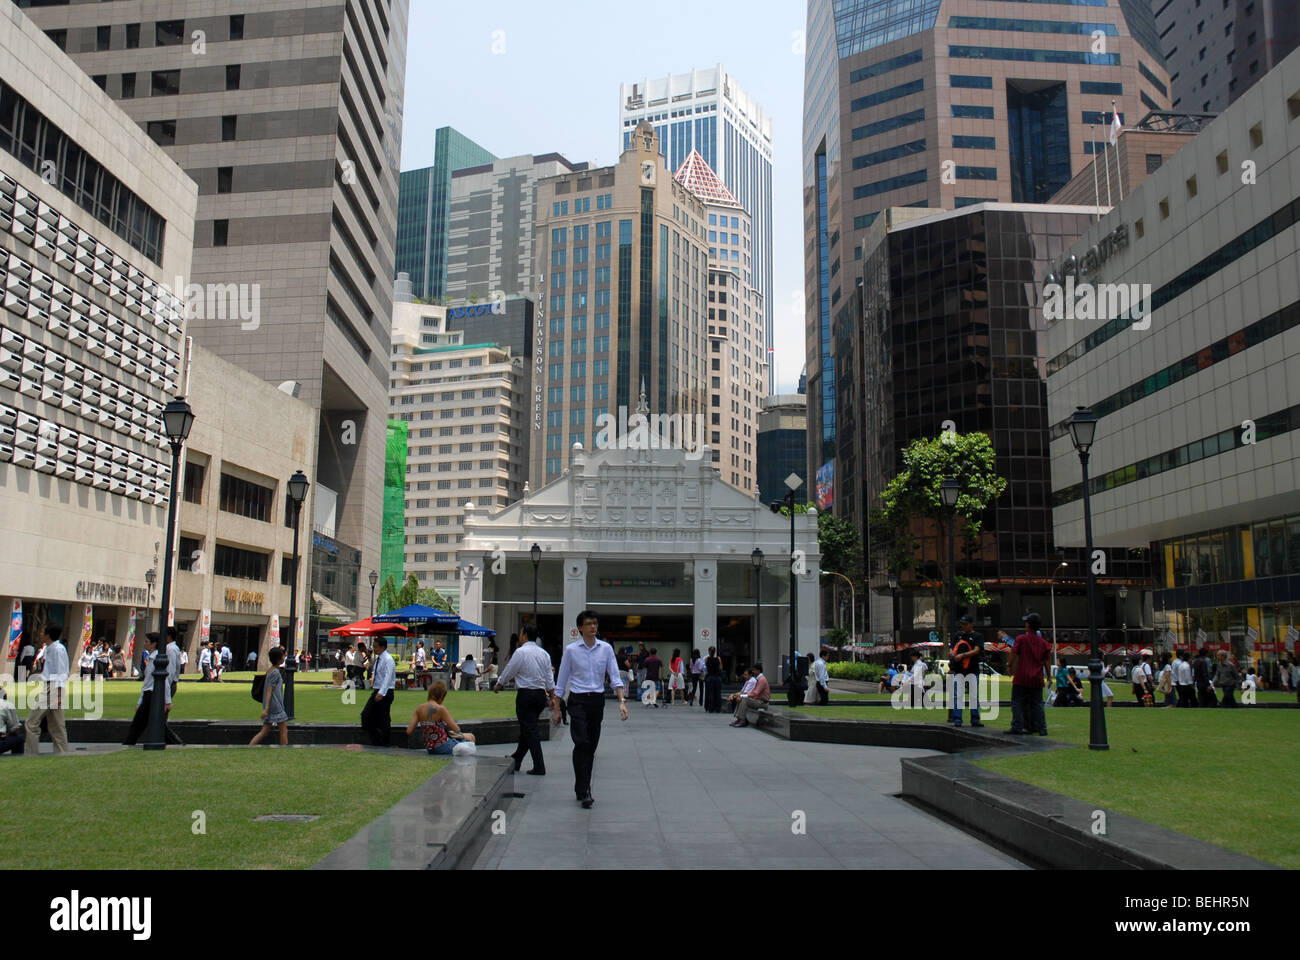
top-left (529, 122), bottom-right (707, 489)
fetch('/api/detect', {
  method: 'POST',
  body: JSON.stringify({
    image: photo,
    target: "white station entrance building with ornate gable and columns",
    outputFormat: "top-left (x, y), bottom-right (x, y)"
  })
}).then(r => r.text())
top-left (458, 437), bottom-right (820, 684)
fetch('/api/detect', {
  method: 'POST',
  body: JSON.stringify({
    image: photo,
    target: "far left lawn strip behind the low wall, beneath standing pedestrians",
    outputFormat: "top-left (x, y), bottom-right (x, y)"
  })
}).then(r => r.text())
top-left (9, 680), bottom-right (515, 723)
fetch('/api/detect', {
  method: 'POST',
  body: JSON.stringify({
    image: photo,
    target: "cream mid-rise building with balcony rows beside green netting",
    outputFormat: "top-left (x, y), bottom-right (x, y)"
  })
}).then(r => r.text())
top-left (390, 295), bottom-right (529, 600)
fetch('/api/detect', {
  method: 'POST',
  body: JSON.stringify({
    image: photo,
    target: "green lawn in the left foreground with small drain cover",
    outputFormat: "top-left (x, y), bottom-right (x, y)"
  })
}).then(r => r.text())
top-left (0, 747), bottom-right (447, 870)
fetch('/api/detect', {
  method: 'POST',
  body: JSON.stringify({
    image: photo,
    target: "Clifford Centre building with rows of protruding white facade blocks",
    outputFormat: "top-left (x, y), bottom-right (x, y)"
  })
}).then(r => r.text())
top-left (0, 5), bottom-right (202, 669)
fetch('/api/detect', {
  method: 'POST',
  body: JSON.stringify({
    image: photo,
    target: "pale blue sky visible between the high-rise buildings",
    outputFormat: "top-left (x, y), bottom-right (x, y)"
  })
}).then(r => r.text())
top-left (402, 0), bottom-right (805, 393)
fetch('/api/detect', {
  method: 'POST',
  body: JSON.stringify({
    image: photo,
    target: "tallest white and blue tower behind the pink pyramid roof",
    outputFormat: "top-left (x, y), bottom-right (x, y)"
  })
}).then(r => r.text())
top-left (619, 64), bottom-right (776, 393)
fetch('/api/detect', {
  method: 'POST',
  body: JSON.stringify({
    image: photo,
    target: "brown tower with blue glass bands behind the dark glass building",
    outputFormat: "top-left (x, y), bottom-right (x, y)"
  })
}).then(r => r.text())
top-left (803, 0), bottom-right (1169, 494)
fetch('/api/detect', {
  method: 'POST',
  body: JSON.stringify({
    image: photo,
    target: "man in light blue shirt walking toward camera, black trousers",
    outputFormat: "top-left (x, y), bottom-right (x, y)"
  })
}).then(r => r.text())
top-left (551, 610), bottom-right (628, 809)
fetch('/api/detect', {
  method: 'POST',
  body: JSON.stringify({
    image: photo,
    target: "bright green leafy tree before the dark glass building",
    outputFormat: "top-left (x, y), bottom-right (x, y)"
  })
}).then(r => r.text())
top-left (870, 433), bottom-right (1006, 624)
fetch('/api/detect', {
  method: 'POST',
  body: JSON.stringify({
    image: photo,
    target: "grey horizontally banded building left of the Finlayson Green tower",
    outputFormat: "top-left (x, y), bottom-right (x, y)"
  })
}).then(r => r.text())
top-left (443, 153), bottom-right (586, 303)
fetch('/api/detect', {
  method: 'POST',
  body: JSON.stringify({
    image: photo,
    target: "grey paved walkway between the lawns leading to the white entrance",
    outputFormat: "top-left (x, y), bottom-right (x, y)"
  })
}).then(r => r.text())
top-left (473, 701), bottom-right (1023, 870)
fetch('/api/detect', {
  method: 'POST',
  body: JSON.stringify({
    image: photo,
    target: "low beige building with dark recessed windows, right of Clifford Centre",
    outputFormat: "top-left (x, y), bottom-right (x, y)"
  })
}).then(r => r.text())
top-left (169, 347), bottom-right (313, 669)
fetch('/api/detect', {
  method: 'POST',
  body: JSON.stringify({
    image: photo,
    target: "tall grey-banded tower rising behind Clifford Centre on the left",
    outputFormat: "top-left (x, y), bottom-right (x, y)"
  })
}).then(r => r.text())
top-left (26, 0), bottom-right (408, 616)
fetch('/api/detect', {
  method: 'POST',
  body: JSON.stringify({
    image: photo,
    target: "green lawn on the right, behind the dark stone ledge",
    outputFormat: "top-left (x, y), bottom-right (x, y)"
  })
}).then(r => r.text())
top-left (802, 691), bottom-right (1300, 869)
